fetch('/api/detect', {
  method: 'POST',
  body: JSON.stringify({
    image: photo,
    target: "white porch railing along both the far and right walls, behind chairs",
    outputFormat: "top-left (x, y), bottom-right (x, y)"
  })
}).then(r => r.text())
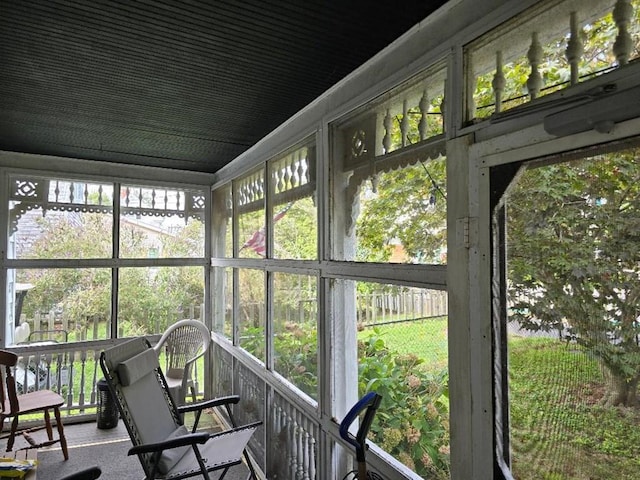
top-left (8, 335), bottom-right (419, 480)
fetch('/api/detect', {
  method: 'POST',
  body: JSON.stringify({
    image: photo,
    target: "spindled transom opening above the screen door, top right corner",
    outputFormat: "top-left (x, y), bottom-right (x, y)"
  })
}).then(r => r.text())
top-left (465, 0), bottom-right (640, 121)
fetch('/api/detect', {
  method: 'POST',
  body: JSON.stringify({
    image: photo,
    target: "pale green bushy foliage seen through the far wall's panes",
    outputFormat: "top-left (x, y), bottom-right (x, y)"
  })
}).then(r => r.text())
top-left (19, 213), bottom-right (204, 335)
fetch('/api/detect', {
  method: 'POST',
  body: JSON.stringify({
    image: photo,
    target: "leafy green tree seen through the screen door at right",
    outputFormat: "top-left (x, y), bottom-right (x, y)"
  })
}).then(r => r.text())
top-left (507, 149), bottom-right (640, 406)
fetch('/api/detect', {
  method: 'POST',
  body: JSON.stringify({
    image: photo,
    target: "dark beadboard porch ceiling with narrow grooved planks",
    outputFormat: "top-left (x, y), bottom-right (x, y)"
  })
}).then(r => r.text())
top-left (0, 0), bottom-right (446, 173)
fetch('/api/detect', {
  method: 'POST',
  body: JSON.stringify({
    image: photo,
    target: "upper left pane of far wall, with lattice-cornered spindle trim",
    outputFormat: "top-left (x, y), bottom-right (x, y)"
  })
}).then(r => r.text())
top-left (8, 177), bottom-right (113, 259)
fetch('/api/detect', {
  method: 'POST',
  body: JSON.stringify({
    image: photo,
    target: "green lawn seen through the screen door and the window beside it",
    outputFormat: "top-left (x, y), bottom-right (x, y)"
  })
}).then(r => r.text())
top-left (359, 318), bottom-right (640, 480)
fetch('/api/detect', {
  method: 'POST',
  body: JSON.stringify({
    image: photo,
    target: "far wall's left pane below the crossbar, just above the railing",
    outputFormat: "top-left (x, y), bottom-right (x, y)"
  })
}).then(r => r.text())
top-left (7, 268), bottom-right (111, 343)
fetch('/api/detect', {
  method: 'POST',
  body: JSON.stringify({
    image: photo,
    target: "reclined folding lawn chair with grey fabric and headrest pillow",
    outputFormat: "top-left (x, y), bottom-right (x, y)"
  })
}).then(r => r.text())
top-left (100, 338), bottom-right (262, 480)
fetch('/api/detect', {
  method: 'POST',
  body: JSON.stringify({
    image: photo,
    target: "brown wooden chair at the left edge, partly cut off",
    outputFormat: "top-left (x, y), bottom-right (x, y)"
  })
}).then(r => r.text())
top-left (0, 350), bottom-right (69, 460)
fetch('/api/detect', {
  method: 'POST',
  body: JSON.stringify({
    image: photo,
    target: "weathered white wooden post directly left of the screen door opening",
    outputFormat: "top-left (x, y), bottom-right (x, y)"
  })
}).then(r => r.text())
top-left (447, 136), bottom-right (494, 480)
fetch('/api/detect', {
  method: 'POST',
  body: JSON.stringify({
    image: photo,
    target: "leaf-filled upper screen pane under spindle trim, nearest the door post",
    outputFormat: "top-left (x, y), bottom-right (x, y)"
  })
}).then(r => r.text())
top-left (355, 157), bottom-right (447, 264)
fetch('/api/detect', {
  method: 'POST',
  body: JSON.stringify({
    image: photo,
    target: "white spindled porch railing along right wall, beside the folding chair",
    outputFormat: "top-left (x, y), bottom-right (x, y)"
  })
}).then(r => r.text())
top-left (211, 335), bottom-right (421, 480)
